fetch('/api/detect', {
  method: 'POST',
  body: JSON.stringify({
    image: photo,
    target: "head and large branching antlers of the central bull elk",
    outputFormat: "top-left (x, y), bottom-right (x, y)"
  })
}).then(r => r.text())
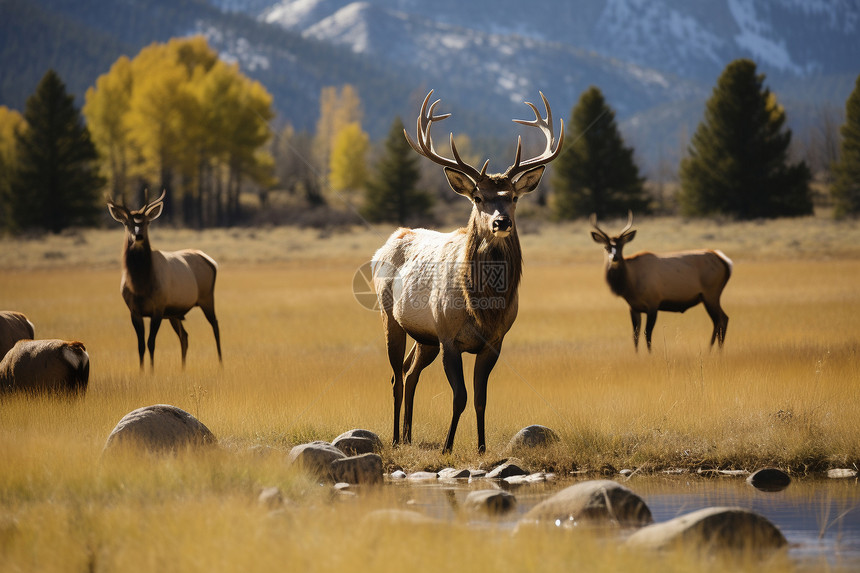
top-left (403, 90), bottom-right (564, 239)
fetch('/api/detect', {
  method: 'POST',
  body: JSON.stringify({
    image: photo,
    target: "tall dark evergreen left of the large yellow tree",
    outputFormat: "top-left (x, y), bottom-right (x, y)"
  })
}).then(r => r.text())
top-left (11, 70), bottom-right (105, 233)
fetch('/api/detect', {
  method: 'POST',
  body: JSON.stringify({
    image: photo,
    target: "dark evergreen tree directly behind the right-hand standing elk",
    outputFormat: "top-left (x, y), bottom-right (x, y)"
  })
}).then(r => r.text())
top-left (552, 86), bottom-right (648, 219)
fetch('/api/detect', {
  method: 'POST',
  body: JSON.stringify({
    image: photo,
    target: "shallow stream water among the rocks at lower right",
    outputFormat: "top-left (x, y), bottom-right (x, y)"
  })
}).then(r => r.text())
top-left (392, 475), bottom-right (860, 571)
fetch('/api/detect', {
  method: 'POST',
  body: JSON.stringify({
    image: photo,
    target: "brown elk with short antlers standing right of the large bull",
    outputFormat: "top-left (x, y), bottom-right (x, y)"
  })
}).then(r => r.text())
top-left (591, 211), bottom-right (732, 352)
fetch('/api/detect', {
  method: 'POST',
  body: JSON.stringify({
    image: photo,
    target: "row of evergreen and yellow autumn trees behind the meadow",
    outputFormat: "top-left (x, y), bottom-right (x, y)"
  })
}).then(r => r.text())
top-left (0, 42), bottom-right (860, 232)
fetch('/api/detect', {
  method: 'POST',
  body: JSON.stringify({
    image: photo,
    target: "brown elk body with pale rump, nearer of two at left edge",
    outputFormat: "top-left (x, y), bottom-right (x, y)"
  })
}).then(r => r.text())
top-left (0, 340), bottom-right (90, 394)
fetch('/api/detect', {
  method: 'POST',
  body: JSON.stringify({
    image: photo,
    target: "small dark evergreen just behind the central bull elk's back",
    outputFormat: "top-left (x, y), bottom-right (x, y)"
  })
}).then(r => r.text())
top-left (361, 117), bottom-right (432, 225)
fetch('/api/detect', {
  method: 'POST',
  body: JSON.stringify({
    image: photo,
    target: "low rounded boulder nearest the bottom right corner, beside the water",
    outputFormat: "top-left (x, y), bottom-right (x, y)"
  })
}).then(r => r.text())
top-left (627, 507), bottom-right (787, 551)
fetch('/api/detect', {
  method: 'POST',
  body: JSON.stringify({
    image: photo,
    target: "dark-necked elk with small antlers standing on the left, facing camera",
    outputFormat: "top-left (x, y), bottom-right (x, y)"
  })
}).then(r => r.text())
top-left (108, 192), bottom-right (221, 370)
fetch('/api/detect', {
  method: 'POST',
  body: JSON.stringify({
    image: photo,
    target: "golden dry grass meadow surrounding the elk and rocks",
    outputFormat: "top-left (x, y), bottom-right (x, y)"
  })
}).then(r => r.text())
top-left (0, 214), bottom-right (860, 571)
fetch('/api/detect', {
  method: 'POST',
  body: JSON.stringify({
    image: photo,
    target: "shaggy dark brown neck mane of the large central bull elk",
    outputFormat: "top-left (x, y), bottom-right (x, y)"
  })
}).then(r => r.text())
top-left (459, 213), bottom-right (523, 335)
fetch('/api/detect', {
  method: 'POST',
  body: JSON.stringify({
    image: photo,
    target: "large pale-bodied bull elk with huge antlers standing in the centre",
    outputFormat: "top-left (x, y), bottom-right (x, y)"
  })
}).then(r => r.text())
top-left (373, 91), bottom-right (564, 452)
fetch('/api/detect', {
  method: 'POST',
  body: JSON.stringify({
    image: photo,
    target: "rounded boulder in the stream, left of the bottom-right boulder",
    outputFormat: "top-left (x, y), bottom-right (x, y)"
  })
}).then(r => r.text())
top-left (518, 480), bottom-right (654, 527)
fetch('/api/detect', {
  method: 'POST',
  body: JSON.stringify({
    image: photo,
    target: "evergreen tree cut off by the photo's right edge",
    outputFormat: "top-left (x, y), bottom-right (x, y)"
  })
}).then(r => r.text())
top-left (831, 76), bottom-right (860, 217)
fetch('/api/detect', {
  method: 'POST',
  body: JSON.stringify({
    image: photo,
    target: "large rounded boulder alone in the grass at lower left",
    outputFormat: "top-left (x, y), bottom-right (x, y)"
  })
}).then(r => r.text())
top-left (103, 404), bottom-right (217, 453)
